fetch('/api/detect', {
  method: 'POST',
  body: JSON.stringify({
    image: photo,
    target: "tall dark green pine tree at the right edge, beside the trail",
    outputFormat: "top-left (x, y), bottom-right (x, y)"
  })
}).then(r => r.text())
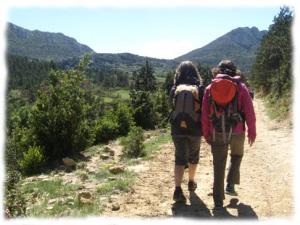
top-left (251, 7), bottom-right (293, 96)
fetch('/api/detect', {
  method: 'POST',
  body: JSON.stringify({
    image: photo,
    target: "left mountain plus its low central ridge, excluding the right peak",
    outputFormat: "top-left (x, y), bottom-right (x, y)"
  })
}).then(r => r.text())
top-left (7, 23), bottom-right (177, 72)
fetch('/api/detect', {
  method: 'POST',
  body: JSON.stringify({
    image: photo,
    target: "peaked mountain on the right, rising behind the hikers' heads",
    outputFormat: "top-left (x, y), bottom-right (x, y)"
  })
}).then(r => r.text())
top-left (175, 27), bottom-right (267, 71)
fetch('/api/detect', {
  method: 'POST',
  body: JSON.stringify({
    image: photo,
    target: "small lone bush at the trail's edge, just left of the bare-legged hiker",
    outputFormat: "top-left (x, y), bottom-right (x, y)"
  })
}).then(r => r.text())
top-left (121, 127), bottom-right (145, 158)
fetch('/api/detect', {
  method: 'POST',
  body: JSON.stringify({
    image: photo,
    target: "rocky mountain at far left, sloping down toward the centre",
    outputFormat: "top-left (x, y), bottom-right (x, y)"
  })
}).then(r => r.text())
top-left (7, 23), bottom-right (94, 61)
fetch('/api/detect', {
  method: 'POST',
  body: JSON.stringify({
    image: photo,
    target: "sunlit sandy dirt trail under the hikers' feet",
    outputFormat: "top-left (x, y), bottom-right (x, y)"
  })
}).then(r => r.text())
top-left (104, 99), bottom-right (294, 219)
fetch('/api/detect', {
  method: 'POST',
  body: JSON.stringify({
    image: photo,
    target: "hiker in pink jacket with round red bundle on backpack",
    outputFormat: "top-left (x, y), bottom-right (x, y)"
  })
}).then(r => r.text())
top-left (201, 60), bottom-right (256, 208)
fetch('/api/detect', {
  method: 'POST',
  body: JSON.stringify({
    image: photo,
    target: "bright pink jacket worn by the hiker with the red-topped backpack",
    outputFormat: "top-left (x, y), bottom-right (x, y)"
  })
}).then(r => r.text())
top-left (201, 75), bottom-right (256, 140)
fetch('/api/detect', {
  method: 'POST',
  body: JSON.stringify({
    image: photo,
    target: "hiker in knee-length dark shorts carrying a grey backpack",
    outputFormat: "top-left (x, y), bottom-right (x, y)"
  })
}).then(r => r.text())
top-left (170, 61), bottom-right (204, 203)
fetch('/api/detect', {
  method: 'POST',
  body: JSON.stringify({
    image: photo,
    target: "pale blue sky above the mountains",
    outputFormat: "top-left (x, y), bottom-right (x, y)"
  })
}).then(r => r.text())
top-left (7, 6), bottom-right (280, 58)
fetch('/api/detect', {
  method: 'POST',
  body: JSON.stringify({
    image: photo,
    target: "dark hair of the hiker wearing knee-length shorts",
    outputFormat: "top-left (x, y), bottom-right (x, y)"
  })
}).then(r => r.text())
top-left (174, 61), bottom-right (202, 85)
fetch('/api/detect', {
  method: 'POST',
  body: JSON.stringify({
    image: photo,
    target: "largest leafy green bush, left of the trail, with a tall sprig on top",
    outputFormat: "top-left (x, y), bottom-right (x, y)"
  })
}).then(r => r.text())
top-left (30, 55), bottom-right (97, 160)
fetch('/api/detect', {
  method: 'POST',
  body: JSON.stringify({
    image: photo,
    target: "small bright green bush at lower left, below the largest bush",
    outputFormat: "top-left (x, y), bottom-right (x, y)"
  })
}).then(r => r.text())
top-left (19, 146), bottom-right (45, 175)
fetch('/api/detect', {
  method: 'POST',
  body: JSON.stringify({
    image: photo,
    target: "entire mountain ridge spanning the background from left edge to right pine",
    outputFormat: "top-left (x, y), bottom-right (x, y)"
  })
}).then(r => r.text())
top-left (7, 23), bottom-right (266, 71)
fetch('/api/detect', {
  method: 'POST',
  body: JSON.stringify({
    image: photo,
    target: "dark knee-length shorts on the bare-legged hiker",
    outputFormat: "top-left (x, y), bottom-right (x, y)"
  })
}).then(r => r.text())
top-left (172, 135), bottom-right (201, 166)
